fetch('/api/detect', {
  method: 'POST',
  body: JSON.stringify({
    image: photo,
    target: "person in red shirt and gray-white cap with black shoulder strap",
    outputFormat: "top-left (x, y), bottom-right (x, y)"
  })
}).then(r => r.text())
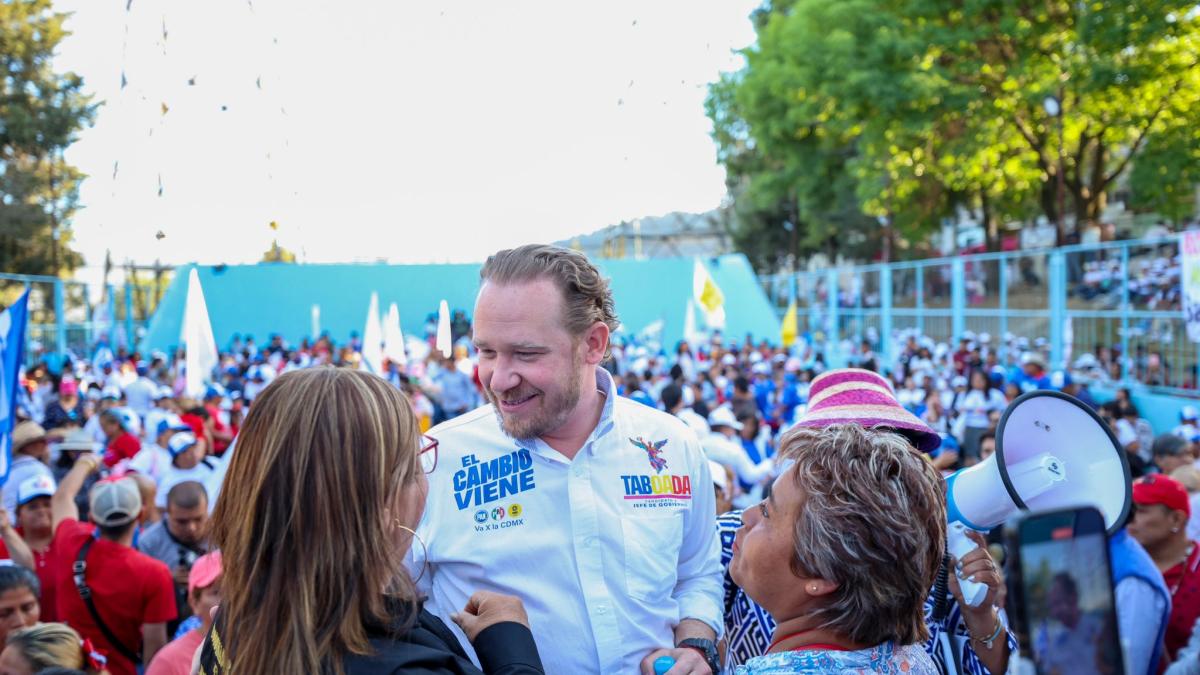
top-left (50, 454), bottom-right (175, 675)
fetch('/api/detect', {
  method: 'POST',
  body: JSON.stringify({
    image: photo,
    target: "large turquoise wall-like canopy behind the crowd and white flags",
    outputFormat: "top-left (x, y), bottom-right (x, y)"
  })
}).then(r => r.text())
top-left (142, 255), bottom-right (779, 351)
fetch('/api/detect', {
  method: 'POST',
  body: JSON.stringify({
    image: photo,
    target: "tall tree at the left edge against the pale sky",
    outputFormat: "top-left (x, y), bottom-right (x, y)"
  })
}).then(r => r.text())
top-left (0, 0), bottom-right (96, 275)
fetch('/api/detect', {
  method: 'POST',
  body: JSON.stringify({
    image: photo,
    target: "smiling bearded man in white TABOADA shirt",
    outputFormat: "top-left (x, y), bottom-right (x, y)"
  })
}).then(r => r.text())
top-left (413, 246), bottom-right (722, 675)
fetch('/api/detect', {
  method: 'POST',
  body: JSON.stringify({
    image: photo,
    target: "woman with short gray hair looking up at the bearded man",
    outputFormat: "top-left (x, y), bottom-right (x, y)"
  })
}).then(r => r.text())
top-left (730, 424), bottom-right (946, 675)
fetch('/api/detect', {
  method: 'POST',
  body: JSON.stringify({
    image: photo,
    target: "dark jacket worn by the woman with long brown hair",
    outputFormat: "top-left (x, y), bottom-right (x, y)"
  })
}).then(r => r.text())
top-left (200, 598), bottom-right (545, 675)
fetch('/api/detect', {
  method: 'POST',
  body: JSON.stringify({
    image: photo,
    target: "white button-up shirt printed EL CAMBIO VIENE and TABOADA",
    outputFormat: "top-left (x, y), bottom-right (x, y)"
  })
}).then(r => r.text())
top-left (410, 369), bottom-right (724, 674)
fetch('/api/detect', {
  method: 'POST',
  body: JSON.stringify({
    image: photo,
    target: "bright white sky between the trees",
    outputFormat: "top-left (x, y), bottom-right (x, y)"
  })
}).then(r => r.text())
top-left (54, 0), bottom-right (758, 275)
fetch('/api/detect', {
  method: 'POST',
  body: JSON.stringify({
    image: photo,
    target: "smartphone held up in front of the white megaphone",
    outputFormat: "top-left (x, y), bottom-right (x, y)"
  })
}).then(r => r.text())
top-left (1004, 507), bottom-right (1124, 675)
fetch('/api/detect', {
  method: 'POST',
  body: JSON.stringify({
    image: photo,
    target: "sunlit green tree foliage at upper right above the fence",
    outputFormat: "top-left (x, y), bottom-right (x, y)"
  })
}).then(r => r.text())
top-left (708, 0), bottom-right (1200, 264)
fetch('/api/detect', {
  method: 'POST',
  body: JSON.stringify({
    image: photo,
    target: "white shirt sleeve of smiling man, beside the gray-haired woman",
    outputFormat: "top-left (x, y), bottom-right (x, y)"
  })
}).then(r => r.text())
top-left (672, 430), bottom-right (725, 638)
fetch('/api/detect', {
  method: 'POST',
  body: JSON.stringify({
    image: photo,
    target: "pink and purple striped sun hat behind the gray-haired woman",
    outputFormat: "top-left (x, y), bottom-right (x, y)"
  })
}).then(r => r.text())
top-left (796, 368), bottom-right (942, 453)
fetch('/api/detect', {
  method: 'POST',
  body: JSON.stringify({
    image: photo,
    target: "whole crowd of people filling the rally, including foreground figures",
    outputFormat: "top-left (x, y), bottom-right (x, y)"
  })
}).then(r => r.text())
top-left (0, 246), bottom-right (1200, 675)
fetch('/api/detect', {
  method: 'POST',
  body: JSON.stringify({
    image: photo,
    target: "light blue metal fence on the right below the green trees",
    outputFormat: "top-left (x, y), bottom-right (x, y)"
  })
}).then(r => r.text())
top-left (761, 237), bottom-right (1200, 395)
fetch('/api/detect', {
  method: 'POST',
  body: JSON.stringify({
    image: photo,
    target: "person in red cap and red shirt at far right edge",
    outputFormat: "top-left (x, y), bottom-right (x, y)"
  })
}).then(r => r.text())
top-left (1128, 473), bottom-right (1200, 663)
